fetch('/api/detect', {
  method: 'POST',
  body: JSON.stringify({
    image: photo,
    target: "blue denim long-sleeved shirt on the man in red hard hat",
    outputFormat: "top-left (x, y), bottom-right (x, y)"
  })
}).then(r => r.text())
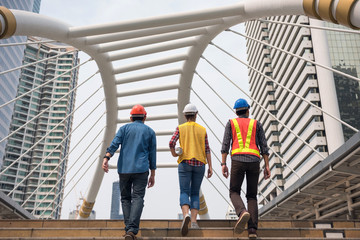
top-left (106, 120), bottom-right (156, 173)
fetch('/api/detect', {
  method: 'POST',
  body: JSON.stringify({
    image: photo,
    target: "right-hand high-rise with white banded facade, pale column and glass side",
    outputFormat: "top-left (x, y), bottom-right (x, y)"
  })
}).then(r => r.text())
top-left (246, 16), bottom-right (360, 204)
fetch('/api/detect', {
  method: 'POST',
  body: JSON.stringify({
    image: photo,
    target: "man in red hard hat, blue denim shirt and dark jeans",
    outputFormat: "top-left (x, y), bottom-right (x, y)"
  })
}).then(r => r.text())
top-left (102, 105), bottom-right (156, 240)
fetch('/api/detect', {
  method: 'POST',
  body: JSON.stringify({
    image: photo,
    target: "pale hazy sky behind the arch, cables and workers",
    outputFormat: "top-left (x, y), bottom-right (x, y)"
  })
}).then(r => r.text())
top-left (40, 0), bottom-right (248, 219)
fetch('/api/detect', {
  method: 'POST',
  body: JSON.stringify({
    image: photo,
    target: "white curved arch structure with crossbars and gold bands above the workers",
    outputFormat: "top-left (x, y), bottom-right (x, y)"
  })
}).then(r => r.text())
top-left (0, 0), bottom-right (360, 218)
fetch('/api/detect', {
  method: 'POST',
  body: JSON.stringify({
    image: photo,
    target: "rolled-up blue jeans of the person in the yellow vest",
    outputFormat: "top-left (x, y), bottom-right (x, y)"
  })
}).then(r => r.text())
top-left (178, 162), bottom-right (205, 209)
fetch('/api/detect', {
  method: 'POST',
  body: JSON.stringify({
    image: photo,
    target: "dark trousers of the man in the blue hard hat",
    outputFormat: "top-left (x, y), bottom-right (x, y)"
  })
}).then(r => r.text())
top-left (230, 161), bottom-right (260, 229)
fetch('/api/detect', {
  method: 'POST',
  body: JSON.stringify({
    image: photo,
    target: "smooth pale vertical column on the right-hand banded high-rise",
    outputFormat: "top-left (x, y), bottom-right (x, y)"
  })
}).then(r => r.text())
top-left (310, 19), bottom-right (344, 154)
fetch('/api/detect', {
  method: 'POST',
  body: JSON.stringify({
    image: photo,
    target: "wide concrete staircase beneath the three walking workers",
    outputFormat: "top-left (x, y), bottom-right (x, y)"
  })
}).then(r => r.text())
top-left (0, 220), bottom-right (360, 240)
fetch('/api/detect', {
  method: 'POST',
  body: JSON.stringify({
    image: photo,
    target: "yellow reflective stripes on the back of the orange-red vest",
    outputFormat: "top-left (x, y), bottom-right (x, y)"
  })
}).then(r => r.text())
top-left (231, 119), bottom-right (260, 157)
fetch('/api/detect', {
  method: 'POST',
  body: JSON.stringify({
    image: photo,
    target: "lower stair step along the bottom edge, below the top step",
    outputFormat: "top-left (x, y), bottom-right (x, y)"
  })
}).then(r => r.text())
top-left (0, 228), bottom-right (360, 239)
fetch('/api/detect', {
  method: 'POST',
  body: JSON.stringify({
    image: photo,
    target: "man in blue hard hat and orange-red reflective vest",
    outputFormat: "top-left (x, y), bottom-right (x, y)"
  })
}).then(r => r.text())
top-left (221, 98), bottom-right (271, 238)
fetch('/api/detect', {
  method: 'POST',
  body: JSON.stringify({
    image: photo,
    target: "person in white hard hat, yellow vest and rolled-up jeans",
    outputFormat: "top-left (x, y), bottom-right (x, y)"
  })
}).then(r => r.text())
top-left (169, 103), bottom-right (213, 236)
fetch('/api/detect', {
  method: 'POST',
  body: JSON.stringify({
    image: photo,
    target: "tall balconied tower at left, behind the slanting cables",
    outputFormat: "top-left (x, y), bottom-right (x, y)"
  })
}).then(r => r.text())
top-left (0, 38), bottom-right (79, 219)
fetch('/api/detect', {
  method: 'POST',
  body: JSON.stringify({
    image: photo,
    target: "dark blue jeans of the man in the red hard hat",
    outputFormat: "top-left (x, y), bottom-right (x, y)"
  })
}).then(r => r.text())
top-left (119, 172), bottom-right (149, 234)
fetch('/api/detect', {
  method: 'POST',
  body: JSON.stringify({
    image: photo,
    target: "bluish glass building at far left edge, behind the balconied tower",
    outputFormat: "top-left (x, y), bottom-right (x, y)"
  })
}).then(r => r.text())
top-left (0, 0), bottom-right (41, 168)
